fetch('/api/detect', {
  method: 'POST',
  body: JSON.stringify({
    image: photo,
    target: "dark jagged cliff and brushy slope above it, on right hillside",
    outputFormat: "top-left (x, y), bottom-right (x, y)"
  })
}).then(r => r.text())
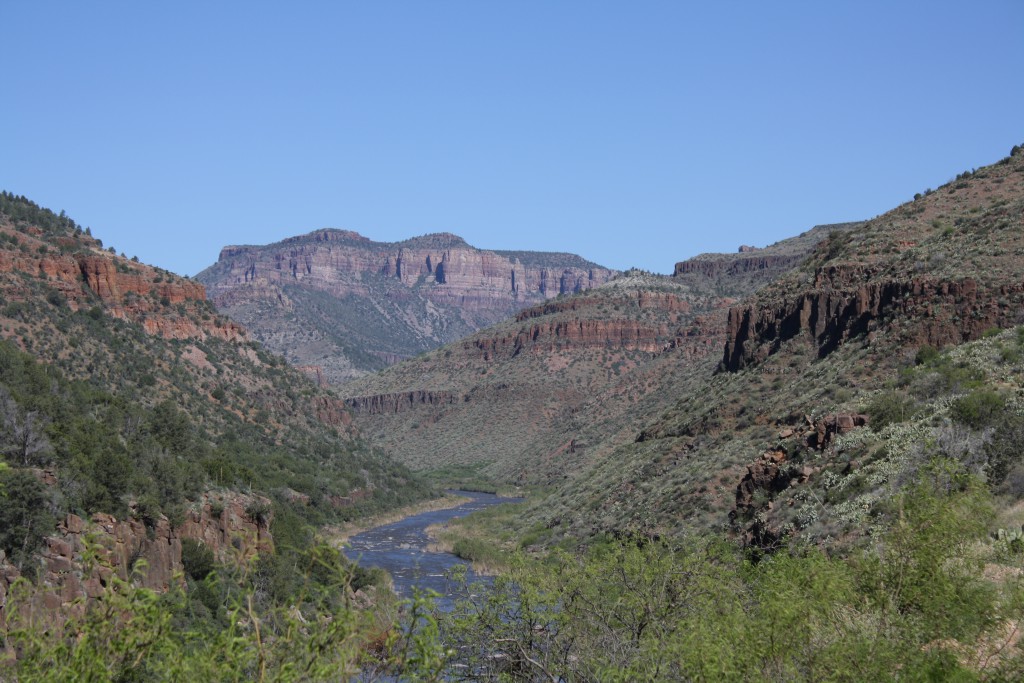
top-left (721, 154), bottom-right (1024, 372)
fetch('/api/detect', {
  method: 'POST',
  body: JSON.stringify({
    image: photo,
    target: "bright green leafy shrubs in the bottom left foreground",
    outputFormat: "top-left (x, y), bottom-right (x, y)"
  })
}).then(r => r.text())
top-left (0, 548), bottom-right (446, 683)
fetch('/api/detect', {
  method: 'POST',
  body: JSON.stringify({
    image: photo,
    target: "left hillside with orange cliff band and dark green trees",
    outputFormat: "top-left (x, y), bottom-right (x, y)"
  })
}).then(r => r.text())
top-left (0, 193), bottom-right (430, 621)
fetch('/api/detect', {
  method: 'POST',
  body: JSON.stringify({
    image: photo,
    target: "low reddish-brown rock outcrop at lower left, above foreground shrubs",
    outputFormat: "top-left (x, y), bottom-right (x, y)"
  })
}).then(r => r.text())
top-left (0, 494), bottom-right (273, 627)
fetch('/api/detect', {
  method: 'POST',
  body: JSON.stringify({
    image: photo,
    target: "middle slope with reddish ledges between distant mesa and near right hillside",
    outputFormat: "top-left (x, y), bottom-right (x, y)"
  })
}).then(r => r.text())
top-left (342, 225), bottom-right (851, 484)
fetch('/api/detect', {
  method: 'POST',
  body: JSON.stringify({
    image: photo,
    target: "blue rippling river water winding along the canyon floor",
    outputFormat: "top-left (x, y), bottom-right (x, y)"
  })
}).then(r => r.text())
top-left (345, 490), bottom-right (522, 605)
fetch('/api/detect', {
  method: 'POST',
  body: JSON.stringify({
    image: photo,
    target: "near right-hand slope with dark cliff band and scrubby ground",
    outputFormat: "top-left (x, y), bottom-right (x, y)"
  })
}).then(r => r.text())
top-left (527, 143), bottom-right (1024, 547)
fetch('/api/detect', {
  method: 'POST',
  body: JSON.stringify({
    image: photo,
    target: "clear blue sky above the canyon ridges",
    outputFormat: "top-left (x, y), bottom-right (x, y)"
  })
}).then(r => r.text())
top-left (0, 0), bottom-right (1024, 274)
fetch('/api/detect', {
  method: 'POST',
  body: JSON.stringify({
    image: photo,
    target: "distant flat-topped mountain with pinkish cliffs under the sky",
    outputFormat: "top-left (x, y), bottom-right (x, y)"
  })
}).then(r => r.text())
top-left (196, 229), bottom-right (615, 385)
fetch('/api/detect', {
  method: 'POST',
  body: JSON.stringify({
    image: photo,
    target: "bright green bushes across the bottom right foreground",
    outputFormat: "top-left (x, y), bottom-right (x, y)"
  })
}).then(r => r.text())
top-left (441, 461), bottom-right (1024, 681)
